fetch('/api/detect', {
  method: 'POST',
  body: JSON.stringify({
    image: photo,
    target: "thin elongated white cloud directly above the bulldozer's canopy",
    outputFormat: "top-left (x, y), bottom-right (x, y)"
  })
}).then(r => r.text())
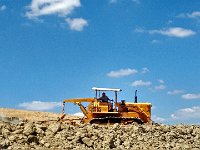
top-left (107, 68), bottom-right (138, 78)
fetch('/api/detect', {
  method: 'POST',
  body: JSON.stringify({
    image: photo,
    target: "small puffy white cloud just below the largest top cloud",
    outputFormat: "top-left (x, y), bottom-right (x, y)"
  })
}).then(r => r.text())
top-left (65, 18), bottom-right (88, 31)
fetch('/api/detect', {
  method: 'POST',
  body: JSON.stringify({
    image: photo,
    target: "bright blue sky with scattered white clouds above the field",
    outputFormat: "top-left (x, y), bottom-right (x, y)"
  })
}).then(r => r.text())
top-left (0, 0), bottom-right (200, 123)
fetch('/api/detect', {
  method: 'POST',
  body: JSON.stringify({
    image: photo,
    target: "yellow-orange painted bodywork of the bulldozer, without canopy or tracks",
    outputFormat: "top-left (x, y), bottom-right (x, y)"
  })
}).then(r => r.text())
top-left (63, 98), bottom-right (151, 124)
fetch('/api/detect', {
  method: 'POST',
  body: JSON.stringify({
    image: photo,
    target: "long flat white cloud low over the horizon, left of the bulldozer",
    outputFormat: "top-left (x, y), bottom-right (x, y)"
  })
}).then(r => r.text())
top-left (18, 101), bottom-right (62, 111)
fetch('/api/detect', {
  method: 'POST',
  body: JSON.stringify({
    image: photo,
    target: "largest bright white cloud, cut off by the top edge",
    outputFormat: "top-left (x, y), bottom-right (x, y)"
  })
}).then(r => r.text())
top-left (25, 0), bottom-right (81, 19)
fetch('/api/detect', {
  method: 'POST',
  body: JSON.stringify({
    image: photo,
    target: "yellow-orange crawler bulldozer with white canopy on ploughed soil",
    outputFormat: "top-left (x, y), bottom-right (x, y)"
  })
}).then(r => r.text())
top-left (61, 87), bottom-right (152, 124)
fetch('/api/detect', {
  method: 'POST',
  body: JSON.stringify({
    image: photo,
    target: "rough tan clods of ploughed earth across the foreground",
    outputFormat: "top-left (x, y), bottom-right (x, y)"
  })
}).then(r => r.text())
top-left (0, 121), bottom-right (200, 150)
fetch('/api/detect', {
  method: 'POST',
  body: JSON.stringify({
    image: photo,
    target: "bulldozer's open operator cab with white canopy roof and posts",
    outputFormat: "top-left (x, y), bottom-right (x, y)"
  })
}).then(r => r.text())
top-left (92, 87), bottom-right (122, 112)
